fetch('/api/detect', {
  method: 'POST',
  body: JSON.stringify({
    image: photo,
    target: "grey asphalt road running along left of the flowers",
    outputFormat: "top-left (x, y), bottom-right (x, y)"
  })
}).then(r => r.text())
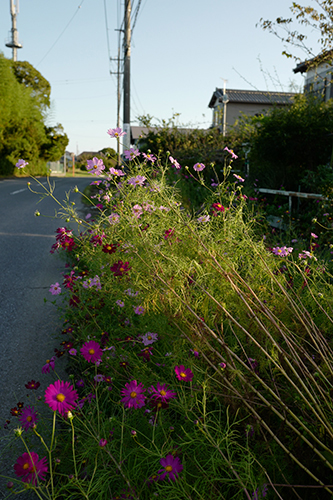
top-left (0, 177), bottom-right (91, 499)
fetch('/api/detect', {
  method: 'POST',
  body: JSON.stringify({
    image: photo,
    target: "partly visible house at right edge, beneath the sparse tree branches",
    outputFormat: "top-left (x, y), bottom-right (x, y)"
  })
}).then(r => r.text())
top-left (293, 50), bottom-right (333, 102)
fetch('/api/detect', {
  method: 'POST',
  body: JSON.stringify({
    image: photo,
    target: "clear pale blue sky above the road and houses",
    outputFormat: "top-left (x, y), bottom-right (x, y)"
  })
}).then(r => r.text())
top-left (0, 0), bottom-right (316, 153)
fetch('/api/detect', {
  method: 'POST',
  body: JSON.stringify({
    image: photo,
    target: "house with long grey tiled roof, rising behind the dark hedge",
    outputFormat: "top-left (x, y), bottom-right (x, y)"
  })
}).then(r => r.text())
top-left (208, 88), bottom-right (297, 132)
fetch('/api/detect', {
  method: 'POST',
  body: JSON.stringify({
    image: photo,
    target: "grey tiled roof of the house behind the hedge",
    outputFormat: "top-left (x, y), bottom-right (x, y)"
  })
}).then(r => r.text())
top-left (208, 89), bottom-right (297, 108)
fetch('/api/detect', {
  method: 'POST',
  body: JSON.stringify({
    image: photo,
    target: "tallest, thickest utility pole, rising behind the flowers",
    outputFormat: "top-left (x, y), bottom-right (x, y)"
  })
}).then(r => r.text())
top-left (123, 0), bottom-right (131, 150)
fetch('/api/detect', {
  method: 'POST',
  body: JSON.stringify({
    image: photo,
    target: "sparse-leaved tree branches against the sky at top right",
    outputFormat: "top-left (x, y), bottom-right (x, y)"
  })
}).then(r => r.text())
top-left (258, 0), bottom-right (333, 67)
